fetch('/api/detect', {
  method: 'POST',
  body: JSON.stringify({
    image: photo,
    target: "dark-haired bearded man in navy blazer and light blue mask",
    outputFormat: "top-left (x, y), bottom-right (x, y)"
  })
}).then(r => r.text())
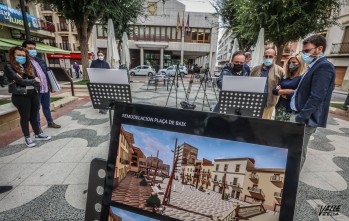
top-left (290, 35), bottom-right (335, 167)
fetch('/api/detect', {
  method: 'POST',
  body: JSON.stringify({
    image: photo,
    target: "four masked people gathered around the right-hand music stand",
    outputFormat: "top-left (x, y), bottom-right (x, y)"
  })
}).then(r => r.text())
top-left (217, 35), bottom-right (335, 165)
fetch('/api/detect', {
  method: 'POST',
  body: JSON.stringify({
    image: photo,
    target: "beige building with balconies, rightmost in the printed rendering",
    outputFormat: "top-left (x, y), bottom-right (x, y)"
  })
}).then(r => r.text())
top-left (240, 167), bottom-right (285, 212)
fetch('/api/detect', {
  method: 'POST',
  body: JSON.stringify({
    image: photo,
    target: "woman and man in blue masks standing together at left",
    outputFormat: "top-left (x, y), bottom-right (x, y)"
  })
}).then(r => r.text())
top-left (4, 41), bottom-right (61, 147)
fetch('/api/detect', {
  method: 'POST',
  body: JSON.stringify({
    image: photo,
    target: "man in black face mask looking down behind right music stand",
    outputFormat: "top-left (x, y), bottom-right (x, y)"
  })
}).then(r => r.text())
top-left (217, 51), bottom-right (248, 89)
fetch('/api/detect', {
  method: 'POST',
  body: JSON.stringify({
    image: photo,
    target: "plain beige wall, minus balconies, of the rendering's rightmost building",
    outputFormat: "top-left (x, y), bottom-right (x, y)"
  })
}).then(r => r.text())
top-left (240, 171), bottom-right (284, 210)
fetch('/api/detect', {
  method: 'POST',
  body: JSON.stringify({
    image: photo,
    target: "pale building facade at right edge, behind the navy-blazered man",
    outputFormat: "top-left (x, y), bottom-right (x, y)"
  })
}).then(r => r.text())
top-left (323, 5), bottom-right (349, 92)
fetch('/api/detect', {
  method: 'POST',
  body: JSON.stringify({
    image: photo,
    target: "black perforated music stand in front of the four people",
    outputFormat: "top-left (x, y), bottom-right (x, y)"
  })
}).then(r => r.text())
top-left (219, 91), bottom-right (267, 118)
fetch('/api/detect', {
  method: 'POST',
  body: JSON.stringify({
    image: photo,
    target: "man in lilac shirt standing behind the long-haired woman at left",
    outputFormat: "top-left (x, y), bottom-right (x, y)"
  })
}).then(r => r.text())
top-left (22, 41), bottom-right (61, 128)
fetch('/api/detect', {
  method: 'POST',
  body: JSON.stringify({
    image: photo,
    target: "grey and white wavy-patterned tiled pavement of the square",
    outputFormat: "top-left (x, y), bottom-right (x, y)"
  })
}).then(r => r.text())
top-left (0, 80), bottom-right (349, 221)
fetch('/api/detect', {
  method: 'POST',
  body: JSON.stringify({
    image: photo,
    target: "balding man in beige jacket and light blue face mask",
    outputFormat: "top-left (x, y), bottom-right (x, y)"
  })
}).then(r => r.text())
top-left (251, 48), bottom-right (284, 119)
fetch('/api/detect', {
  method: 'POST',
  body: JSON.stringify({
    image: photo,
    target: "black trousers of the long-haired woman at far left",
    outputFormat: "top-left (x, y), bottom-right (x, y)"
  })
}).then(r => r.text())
top-left (12, 89), bottom-right (40, 137)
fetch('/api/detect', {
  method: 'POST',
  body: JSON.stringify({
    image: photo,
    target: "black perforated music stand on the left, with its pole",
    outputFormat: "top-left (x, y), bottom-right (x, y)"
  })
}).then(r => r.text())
top-left (87, 83), bottom-right (132, 126)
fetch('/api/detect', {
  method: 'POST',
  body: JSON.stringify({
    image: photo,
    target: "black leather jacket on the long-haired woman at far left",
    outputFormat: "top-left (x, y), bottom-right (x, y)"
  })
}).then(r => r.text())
top-left (4, 63), bottom-right (40, 91)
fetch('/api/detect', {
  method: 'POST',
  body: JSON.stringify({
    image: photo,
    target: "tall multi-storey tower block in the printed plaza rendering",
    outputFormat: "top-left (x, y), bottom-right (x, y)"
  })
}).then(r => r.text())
top-left (174, 143), bottom-right (198, 180)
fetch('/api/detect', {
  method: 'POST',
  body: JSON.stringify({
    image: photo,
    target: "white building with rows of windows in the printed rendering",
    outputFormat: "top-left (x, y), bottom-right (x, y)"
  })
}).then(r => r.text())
top-left (210, 158), bottom-right (255, 199)
